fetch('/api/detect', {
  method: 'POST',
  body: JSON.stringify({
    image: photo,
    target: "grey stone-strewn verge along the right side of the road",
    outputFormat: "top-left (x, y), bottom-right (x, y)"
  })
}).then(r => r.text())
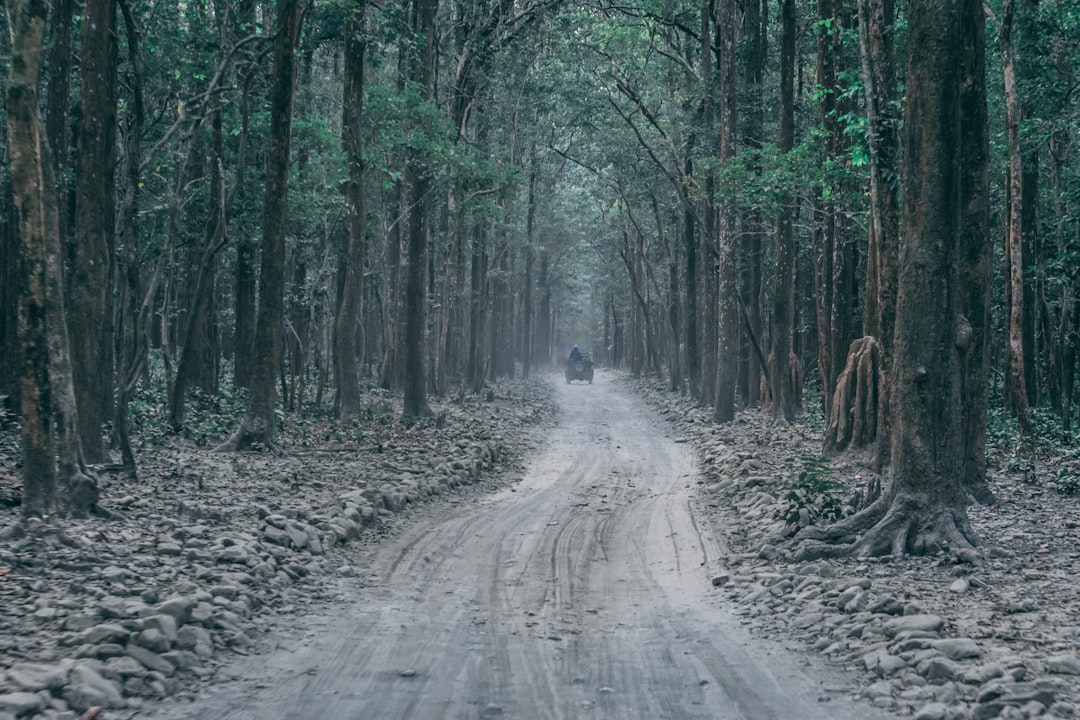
top-left (632, 375), bottom-right (1080, 720)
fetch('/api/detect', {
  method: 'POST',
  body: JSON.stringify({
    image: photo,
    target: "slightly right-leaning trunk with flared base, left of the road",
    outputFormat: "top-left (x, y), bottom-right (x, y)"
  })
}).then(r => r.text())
top-left (218, 0), bottom-right (306, 451)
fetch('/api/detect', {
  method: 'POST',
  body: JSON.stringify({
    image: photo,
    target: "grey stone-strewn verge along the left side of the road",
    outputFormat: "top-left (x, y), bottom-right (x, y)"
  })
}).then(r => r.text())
top-left (0, 382), bottom-right (554, 720)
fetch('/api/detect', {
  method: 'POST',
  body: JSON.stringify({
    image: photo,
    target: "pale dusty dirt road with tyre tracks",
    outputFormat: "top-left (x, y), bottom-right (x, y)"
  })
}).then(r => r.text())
top-left (140, 373), bottom-right (877, 720)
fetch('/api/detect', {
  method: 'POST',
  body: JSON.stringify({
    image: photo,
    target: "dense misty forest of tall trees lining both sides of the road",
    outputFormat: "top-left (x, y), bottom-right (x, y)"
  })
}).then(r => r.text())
top-left (0, 0), bottom-right (1080, 556)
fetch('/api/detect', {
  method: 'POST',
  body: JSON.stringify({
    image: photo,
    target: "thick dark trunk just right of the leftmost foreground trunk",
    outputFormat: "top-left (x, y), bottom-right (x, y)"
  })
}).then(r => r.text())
top-left (68, 0), bottom-right (118, 463)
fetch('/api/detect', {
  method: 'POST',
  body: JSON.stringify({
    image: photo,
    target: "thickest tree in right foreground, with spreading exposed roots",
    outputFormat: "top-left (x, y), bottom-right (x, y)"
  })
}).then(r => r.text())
top-left (800, 0), bottom-right (989, 557)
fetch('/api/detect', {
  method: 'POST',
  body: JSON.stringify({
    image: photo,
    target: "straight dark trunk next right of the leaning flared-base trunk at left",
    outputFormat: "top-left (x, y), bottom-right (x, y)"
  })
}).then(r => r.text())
top-left (334, 5), bottom-right (367, 420)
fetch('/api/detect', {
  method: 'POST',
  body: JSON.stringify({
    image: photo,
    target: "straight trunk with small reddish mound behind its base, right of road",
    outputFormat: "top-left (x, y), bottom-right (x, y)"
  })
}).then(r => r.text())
top-left (769, 0), bottom-right (796, 423)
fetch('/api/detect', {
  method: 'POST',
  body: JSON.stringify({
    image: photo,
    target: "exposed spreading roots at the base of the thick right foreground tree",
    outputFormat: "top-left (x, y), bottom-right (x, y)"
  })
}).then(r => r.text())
top-left (795, 495), bottom-right (981, 561)
